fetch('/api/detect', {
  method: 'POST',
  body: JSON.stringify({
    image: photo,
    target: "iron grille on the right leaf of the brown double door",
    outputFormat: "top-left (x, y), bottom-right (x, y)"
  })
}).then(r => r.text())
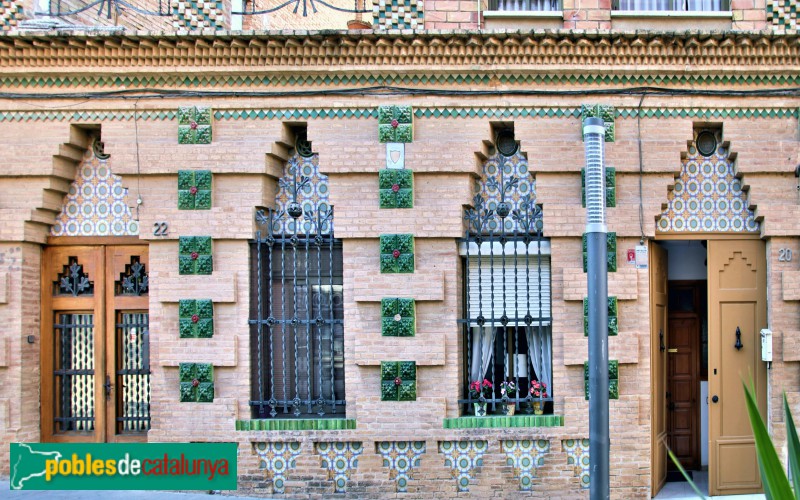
top-left (116, 312), bottom-right (150, 434)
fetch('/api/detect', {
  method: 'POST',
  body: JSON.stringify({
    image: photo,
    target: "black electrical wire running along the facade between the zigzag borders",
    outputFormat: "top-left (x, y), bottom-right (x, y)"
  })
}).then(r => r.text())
top-left (0, 86), bottom-right (800, 100)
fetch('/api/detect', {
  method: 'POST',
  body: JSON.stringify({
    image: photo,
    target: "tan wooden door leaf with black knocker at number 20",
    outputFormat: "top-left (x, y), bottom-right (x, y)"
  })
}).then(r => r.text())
top-left (708, 240), bottom-right (767, 496)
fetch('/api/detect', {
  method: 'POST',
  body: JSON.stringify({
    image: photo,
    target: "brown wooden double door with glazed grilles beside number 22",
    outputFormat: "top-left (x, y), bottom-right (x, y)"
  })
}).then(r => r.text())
top-left (41, 245), bottom-right (150, 442)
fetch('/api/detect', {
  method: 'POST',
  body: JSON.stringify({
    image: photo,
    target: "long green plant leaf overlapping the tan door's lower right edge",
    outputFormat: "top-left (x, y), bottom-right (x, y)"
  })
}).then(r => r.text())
top-left (742, 379), bottom-right (795, 500)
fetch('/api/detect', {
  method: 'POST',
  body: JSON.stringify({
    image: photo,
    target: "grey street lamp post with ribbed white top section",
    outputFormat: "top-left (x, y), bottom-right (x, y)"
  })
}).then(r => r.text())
top-left (583, 117), bottom-right (610, 500)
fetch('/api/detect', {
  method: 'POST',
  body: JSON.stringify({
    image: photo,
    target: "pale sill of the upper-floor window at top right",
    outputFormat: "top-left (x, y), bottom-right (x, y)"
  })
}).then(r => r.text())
top-left (611, 10), bottom-right (733, 31)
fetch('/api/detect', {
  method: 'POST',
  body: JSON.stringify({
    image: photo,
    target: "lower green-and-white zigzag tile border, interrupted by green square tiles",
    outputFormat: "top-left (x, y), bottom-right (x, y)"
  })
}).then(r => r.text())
top-left (0, 107), bottom-right (800, 122)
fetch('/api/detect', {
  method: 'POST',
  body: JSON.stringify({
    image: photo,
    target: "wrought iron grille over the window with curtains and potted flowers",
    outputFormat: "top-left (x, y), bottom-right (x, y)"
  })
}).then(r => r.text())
top-left (459, 152), bottom-right (553, 415)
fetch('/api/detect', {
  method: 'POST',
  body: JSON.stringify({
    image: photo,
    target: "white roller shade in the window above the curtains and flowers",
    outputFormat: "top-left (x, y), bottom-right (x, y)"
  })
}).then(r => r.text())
top-left (467, 254), bottom-right (550, 327)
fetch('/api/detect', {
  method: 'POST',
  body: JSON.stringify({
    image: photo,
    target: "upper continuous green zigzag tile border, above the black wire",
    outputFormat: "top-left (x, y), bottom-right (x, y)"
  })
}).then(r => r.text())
top-left (0, 73), bottom-right (800, 89)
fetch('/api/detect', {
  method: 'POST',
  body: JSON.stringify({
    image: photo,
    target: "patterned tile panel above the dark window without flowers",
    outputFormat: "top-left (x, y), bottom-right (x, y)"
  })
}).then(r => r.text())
top-left (272, 153), bottom-right (333, 234)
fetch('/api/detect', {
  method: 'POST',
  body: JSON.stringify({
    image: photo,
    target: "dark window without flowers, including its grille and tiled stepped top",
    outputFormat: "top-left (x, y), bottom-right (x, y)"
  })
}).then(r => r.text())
top-left (250, 149), bottom-right (345, 418)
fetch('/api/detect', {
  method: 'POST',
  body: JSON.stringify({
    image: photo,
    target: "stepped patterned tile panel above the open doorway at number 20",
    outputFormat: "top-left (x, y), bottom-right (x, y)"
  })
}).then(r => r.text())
top-left (656, 142), bottom-right (760, 233)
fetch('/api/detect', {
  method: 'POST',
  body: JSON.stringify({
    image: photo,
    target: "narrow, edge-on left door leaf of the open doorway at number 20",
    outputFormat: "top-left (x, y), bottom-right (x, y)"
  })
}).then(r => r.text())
top-left (650, 243), bottom-right (669, 496)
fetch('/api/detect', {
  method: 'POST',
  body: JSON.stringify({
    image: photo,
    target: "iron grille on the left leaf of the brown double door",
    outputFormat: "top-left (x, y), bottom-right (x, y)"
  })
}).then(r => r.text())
top-left (53, 313), bottom-right (95, 432)
